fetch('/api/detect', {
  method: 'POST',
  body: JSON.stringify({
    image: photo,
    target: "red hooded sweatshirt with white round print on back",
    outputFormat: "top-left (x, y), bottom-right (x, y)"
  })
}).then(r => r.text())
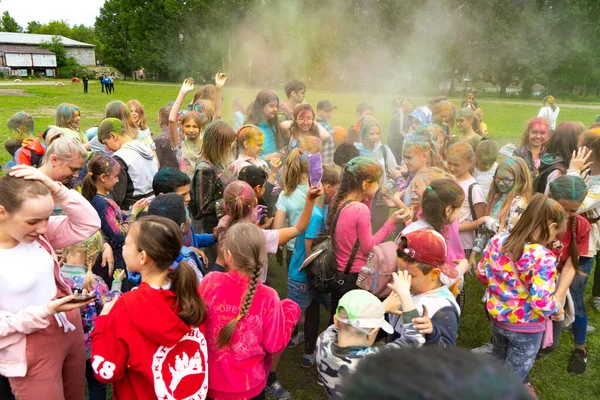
top-left (91, 283), bottom-right (208, 400)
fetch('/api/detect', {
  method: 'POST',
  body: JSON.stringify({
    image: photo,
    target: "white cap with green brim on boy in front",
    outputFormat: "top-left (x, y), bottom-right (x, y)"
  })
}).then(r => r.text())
top-left (335, 289), bottom-right (394, 333)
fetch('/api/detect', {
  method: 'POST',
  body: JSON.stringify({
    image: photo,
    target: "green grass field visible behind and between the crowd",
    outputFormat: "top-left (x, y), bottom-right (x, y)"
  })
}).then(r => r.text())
top-left (0, 81), bottom-right (600, 400)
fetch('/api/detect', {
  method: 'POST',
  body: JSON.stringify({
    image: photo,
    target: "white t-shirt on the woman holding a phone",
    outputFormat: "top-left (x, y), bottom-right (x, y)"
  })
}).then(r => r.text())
top-left (0, 242), bottom-right (56, 314)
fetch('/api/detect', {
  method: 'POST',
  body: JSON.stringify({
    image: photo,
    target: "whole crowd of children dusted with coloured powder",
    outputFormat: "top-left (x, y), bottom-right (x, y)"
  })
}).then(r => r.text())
top-left (0, 76), bottom-right (600, 400)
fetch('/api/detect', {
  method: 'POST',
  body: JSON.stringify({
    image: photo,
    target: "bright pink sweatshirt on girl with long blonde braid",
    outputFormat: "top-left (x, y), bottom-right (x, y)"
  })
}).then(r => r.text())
top-left (200, 271), bottom-right (300, 400)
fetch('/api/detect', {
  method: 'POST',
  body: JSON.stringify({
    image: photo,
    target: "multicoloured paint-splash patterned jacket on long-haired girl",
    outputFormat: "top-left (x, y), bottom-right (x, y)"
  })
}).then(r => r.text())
top-left (477, 232), bottom-right (558, 332)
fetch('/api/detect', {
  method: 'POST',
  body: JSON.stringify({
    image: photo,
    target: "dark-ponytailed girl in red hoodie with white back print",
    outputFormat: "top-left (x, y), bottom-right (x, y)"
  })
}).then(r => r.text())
top-left (92, 216), bottom-right (208, 399)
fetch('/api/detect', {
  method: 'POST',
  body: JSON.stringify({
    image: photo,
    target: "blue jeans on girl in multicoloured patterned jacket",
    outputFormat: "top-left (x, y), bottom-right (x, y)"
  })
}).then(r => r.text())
top-left (492, 323), bottom-right (544, 382)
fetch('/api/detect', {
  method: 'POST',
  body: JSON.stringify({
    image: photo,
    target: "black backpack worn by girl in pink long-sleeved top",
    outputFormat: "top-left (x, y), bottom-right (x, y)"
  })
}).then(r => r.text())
top-left (301, 200), bottom-right (359, 293)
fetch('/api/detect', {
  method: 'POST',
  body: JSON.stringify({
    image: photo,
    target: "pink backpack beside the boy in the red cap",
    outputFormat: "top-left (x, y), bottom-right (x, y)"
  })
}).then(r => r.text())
top-left (356, 241), bottom-right (398, 298)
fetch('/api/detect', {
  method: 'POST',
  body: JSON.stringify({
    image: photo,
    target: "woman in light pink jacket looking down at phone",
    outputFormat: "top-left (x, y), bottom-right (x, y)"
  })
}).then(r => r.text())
top-left (0, 165), bottom-right (100, 400)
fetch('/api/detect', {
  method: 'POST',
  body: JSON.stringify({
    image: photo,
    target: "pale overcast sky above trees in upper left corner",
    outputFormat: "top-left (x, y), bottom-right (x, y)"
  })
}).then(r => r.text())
top-left (0, 0), bottom-right (104, 29)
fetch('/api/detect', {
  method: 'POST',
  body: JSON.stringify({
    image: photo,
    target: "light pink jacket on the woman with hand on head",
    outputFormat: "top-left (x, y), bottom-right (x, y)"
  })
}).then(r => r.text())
top-left (0, 186), bottom-right (100, 377)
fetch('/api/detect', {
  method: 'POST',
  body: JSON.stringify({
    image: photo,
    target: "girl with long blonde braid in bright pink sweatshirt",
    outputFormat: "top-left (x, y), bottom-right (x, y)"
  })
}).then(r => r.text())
top-left (200, 222), bottom-right (300, 399)
